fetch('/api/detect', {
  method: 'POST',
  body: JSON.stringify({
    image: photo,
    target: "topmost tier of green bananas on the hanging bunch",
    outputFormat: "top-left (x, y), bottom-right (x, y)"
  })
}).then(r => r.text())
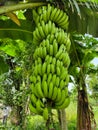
top-left (33, 4), bottom-right (68, 30)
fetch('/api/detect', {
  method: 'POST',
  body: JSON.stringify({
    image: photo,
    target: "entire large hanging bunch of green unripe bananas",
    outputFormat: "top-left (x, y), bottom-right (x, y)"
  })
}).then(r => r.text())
top-left (29, 4), bottom-right (71, 120)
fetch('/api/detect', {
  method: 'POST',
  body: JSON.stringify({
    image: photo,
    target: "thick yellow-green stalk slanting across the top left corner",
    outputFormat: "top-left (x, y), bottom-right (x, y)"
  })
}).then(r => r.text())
top-left (0, 2), bottom-right (46, 14)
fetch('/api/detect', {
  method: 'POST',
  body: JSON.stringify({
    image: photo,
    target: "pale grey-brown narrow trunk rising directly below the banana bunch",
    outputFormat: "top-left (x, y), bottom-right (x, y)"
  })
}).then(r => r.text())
top-left (58, 109), bottom-right (67, 130)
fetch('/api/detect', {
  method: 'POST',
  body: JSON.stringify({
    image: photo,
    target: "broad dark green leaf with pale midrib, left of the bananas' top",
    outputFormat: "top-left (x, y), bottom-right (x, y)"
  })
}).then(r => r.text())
top-left (0, 20), bottom-right (34, 42)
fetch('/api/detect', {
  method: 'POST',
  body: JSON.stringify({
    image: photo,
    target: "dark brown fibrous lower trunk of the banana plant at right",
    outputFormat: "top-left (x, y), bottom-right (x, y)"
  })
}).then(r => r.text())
top-left (77, 90), bottom-right (91, 130)
